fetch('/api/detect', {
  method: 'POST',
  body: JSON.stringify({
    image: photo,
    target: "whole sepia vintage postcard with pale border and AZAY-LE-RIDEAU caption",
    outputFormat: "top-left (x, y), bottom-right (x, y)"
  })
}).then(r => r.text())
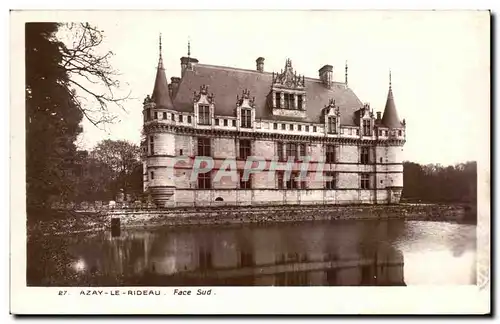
top-left (10, 10), bottom-right (491, 314)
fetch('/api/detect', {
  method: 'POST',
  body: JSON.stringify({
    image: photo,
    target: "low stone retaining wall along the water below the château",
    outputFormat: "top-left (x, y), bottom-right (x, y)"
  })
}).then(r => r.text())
top-left (105, 204), bottom-right (465, 227)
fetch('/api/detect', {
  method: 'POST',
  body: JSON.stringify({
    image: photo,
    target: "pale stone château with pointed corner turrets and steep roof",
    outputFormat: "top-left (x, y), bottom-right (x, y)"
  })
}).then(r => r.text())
top-left (141, 39), bottom-right (406, 207)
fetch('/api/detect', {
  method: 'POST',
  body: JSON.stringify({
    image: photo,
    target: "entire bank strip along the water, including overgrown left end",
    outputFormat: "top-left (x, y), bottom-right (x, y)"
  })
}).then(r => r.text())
top-left (28, 204), bottom-right (475, 235)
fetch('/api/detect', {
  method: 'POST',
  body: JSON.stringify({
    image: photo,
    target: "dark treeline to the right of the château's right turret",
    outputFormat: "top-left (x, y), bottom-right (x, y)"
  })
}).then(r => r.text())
top-left (401, 162), bottom-right (477, 203)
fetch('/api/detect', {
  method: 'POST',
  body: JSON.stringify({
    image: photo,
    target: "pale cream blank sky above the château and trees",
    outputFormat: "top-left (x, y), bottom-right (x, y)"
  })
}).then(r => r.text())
top-left (68, 11), bottom-right (490, 165)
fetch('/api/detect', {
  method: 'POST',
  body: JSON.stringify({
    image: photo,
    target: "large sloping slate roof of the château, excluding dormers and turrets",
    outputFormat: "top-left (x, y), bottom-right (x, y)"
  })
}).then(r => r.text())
top-left (173, 64), bottom-right (362, 126)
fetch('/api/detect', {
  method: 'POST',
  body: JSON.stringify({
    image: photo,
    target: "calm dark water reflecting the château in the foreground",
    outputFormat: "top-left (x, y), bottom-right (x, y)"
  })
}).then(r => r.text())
top-left (27, 220), bottom-right (476, 286)
